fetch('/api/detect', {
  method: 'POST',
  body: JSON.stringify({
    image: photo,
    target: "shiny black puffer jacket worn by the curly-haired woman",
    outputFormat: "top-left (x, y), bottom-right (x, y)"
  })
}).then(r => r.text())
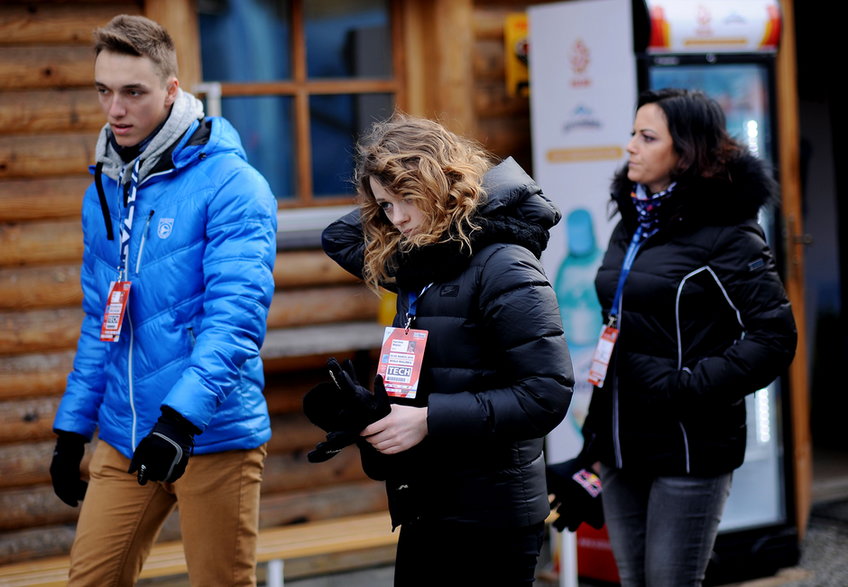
top-left (323, 160), bottom-right (574, 527)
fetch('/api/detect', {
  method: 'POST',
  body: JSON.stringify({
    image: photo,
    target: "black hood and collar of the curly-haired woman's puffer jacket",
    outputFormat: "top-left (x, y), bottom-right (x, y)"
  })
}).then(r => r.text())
top-left (395, 158), bottom-right (562, 289)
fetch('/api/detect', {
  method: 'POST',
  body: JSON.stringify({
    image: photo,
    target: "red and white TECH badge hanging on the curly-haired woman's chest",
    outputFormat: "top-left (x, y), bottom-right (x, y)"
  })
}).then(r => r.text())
top-left (377, 326), bottom-right (427, 399)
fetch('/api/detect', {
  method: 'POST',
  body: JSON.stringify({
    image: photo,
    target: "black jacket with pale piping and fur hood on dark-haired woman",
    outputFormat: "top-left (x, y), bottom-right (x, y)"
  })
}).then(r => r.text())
top-left (583, 155), bottom-right (797, 475)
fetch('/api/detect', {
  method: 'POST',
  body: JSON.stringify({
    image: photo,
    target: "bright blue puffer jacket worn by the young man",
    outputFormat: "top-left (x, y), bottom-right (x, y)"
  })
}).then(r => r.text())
top-left (54, 113), bottom-right (276, 457)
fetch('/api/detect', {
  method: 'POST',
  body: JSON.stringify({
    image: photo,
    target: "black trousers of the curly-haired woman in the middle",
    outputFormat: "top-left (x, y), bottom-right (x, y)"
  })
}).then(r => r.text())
top-left (395, 521), bottom-right (545, 587)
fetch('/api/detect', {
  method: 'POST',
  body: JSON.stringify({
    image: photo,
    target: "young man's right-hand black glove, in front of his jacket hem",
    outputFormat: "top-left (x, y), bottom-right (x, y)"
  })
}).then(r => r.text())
top-left (127, 406), bottom-right (200, 485)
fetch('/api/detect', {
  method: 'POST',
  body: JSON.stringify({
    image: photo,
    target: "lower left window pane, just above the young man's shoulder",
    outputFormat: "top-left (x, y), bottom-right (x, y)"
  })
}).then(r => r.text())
top-left (221, 96), bottom-right (295, 199)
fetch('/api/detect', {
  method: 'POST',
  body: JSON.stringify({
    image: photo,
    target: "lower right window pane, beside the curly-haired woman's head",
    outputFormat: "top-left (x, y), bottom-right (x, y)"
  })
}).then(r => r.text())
top-left (309, 94), bottom-right (394, 197)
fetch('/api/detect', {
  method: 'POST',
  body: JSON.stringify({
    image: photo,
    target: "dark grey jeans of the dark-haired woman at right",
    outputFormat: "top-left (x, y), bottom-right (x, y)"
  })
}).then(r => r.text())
top-left (601, 466), bottom-right (732, 587)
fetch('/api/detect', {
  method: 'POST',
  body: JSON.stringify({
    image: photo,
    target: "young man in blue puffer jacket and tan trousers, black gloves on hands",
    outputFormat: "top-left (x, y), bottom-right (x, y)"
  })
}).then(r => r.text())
top-left (50, 15), bottom-right (276, 585)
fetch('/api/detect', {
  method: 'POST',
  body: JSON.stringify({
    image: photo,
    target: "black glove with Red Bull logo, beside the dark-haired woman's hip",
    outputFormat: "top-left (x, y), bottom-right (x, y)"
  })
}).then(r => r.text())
top-left (545, 459), bottom-right (604, 532)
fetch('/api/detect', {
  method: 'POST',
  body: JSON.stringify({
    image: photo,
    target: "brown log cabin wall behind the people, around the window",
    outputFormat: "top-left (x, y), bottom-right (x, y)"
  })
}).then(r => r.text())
top-left (0, 0), bottom-right (548, 564)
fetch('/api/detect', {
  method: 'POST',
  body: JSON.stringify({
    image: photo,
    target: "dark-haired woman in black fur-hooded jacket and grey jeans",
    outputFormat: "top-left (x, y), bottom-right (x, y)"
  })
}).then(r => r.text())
top-left (583, 89), bottom-right (796, 587)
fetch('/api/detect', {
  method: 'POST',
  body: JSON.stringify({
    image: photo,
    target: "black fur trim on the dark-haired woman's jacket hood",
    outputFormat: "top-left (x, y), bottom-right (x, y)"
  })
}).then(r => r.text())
top-left (612, 152), bottom-right (778, 229)
